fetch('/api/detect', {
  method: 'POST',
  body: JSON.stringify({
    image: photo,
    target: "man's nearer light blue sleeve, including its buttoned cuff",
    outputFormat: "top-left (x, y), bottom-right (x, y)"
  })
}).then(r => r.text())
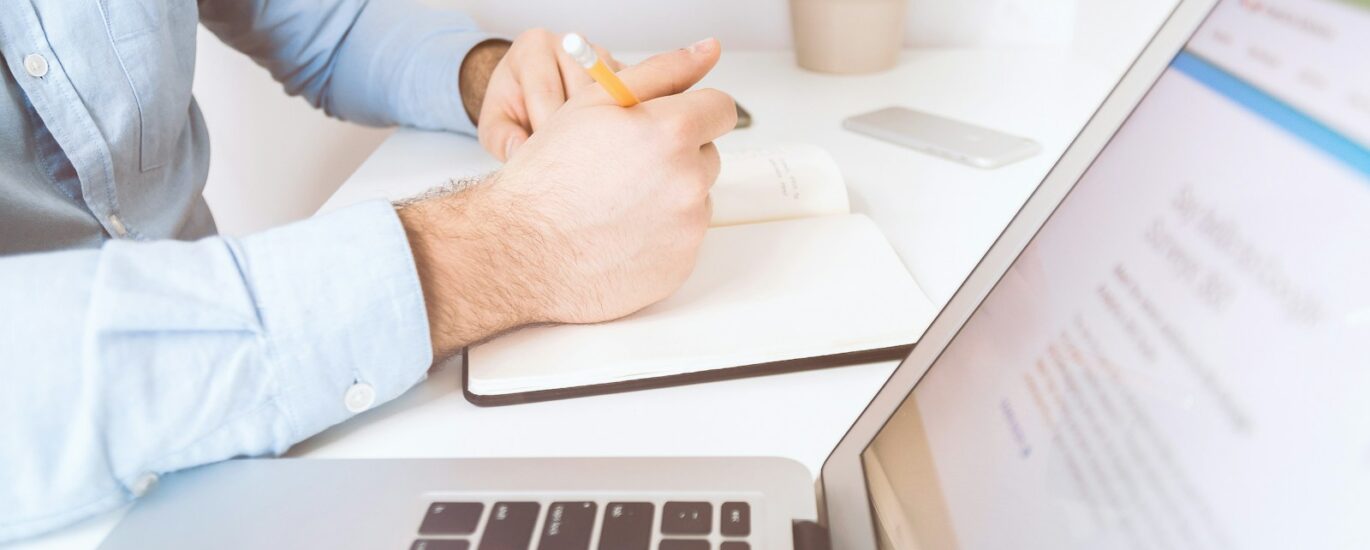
top-left (0, 202), bottom-right (432, 542)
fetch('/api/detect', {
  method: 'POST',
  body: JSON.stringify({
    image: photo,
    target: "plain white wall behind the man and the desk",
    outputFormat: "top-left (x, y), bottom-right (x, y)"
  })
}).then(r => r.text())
top-left (195, 0), bottom-right (1171, 235)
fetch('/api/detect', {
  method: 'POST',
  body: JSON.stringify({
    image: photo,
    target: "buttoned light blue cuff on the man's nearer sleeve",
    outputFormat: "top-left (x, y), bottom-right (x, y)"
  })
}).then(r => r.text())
top-left (238, 200), bottom-right (433, 444)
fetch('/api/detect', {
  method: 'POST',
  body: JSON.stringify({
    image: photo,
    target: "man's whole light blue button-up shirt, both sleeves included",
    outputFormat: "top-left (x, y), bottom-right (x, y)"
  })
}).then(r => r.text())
top-left (0, 0), bottom-right (488, 540)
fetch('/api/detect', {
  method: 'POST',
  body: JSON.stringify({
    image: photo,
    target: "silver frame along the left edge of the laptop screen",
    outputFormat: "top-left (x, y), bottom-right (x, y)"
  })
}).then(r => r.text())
top-left (818, 0), bottom-right (1218, 549)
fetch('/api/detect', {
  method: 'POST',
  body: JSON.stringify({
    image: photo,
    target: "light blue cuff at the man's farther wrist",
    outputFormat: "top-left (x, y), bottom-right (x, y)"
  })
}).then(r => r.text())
top-left (406, 30), bottom-right (496, 134)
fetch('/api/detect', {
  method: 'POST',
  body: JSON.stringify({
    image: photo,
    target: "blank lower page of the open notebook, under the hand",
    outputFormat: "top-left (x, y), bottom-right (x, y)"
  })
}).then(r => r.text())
top-left (467, 215), bottom-right (936, 395)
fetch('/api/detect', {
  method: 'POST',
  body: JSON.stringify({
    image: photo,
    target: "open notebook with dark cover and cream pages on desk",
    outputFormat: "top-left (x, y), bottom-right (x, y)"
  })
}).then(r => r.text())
top-left (464, 145), bottom-right (936, 405)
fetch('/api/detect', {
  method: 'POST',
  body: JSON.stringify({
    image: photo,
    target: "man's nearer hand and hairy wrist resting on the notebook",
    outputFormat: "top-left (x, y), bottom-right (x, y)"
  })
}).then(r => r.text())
top-left (399, 40), bottom-right (737, 358)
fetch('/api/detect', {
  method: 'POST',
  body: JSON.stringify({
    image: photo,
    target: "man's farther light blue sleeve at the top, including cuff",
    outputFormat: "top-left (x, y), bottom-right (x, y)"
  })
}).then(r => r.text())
top-left (200, 0), bottom-right (490, 133)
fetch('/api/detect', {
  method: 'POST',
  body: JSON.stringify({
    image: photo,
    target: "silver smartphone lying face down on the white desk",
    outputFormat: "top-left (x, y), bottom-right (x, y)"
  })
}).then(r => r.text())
top-left (843, 107), bottom-right (1041, 169)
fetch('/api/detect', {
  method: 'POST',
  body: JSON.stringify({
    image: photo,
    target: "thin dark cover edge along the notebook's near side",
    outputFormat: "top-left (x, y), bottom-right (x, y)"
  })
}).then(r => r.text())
top-left (462, 344), bottom-right (914, 407)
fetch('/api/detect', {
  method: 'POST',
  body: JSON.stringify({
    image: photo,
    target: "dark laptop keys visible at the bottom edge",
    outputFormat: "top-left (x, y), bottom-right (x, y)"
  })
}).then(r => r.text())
top-left (410, 501), bottom-right (752, 550)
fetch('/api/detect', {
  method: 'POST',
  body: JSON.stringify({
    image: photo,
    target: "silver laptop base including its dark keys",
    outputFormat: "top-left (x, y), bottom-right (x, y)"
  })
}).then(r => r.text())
top-left (100, 458), bottom-right (817, 550)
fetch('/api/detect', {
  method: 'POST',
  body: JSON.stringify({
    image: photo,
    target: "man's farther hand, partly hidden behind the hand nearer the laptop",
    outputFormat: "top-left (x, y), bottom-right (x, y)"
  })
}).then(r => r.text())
top-left (462, 29), bottom-right (622, 162)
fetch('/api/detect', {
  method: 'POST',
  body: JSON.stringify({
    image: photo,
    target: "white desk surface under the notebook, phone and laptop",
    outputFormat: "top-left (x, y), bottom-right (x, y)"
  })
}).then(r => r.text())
top-left (14, 36), bottom-right (1159, 549)
